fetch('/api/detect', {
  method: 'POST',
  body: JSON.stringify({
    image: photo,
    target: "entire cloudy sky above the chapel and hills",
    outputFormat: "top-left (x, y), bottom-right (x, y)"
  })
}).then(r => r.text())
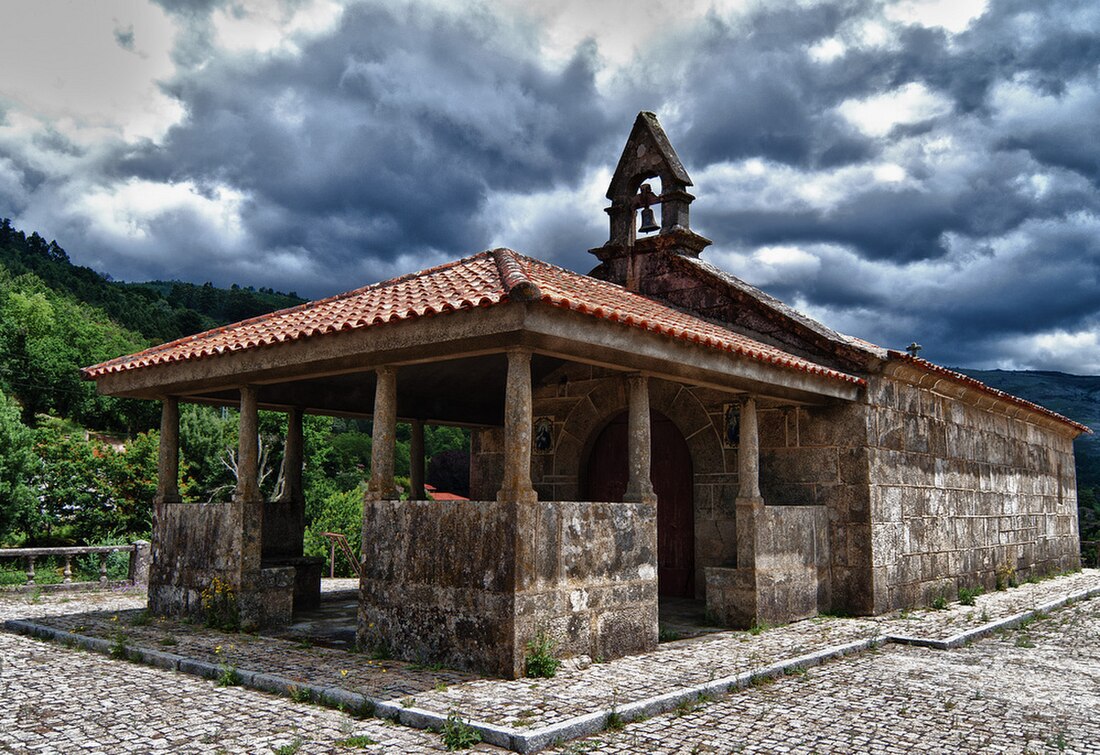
top-left (0, 0), bottom-right (1100, 374)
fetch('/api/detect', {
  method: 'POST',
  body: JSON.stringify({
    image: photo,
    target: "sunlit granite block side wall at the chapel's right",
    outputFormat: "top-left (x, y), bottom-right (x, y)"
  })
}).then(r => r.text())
top-left (868, 376), bottom-right (1080, 612)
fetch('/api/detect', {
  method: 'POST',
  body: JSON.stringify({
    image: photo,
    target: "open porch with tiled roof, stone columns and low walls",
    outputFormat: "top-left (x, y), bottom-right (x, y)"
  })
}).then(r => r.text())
top-left (83, 250), bottom-right (858, 677)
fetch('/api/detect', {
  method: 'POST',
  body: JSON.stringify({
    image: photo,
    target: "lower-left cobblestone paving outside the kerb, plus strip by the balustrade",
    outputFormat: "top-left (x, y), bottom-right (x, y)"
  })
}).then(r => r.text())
top-left (0, 593), bottom-right (504, 755)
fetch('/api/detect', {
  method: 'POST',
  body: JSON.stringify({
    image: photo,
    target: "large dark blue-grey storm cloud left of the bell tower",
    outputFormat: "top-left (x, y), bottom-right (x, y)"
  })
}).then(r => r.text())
top-left (112, 6), bottom-right (608, 291)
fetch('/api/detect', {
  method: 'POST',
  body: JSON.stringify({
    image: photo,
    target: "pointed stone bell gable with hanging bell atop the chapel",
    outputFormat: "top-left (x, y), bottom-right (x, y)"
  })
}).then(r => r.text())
top-left (589, 111), bottom-right (711, 293)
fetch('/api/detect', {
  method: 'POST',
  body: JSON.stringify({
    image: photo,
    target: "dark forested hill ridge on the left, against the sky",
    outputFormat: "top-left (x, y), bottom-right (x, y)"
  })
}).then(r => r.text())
top-left (0, 219), bottom-right (305, 342)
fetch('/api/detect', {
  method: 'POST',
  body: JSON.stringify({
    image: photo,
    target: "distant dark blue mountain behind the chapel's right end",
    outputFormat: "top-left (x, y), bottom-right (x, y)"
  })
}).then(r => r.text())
top-left (953, 368), bottom-right (1100, 540)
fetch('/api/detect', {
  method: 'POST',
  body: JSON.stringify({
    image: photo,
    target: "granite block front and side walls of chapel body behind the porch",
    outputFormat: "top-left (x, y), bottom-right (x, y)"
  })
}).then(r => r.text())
top-left (472, 364), bottom-right (1079, 617)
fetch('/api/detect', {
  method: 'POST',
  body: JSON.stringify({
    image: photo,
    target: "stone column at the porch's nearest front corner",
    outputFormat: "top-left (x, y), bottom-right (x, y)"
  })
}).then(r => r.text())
top-left (496, 348), bottom-right (538, 503)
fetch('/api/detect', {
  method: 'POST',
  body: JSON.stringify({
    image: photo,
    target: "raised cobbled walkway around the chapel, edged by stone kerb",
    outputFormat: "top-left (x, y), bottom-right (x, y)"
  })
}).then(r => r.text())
top-left (6, 570), bottom-right (1100, 752)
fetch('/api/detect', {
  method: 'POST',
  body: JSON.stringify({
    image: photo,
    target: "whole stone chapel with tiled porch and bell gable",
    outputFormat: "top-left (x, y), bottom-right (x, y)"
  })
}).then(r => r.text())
top-left (84, 112), bottom-right (1089, 677)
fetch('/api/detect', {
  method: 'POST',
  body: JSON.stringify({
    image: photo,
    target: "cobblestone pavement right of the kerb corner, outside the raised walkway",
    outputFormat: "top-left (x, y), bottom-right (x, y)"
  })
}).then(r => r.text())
top-left (556, 599), bottom-right (1100, 755)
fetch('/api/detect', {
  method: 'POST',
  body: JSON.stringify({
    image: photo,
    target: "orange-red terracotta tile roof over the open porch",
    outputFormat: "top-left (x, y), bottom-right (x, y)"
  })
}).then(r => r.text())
top-left (81, 249), bottom-right (866, 385)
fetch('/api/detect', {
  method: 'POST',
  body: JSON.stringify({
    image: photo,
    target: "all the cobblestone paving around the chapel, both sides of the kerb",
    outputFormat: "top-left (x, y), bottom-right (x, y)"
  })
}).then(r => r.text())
top-left (0, 570), bottom-right (1100, 753)
